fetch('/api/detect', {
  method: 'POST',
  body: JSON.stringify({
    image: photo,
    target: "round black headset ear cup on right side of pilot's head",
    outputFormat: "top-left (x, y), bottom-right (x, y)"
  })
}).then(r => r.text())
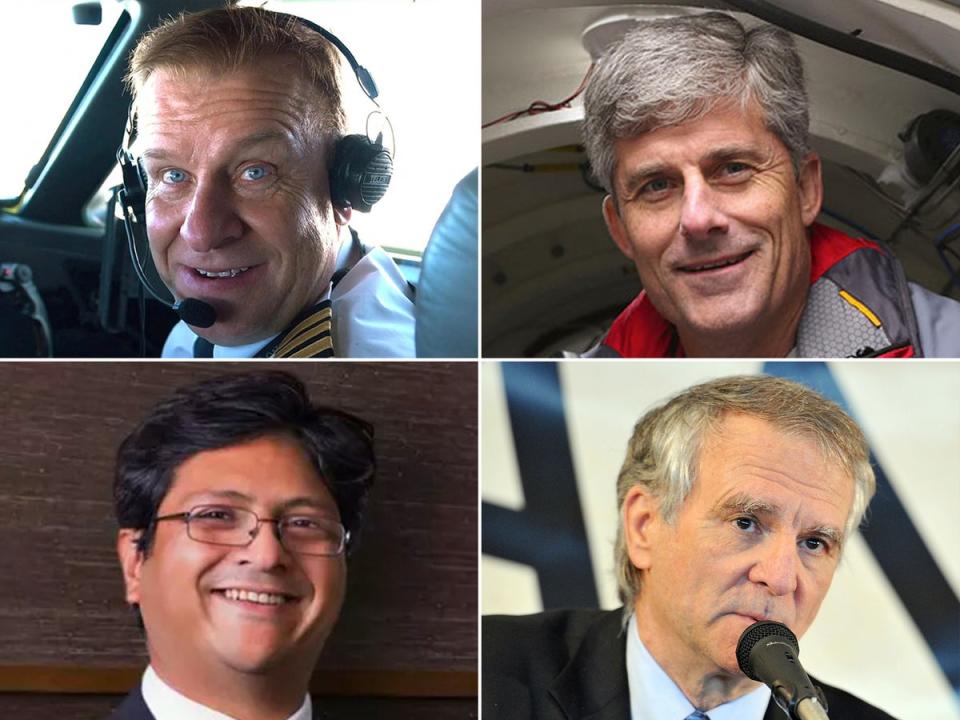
top-left (330, 135), bottom-right (393, 212)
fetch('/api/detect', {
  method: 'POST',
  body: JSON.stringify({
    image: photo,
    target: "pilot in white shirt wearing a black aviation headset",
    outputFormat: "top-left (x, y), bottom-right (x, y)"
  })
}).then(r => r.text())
top-left (119, 2), bottom-right (414, 358)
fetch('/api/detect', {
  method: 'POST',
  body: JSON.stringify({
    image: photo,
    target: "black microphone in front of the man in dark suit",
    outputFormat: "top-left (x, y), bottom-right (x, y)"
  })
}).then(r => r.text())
top-left (737, 620), bottom-right (829, 720)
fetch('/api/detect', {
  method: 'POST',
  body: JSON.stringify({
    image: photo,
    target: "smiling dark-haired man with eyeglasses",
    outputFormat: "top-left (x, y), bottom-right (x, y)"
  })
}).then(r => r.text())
top-left (111, 372), bottom-right (375, 720)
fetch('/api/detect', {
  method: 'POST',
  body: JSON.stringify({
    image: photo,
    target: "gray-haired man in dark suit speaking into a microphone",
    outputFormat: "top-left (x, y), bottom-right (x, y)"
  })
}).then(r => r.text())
top-left (483, 376), bottom-right (890, 720)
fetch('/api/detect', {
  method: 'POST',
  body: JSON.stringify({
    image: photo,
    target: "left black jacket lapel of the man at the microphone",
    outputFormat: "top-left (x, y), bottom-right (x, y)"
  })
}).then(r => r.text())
top-left (550, 610), bottom-right (630, 720)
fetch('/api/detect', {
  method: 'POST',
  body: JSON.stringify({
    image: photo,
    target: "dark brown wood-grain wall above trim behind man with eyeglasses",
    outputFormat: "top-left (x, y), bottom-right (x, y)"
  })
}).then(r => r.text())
top-left (0, 362), bottom-right (477, 688)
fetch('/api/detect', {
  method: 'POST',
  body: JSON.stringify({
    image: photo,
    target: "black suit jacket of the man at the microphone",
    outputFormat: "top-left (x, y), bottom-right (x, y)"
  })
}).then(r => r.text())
top-left (481, 610), bottom-right (893, 720)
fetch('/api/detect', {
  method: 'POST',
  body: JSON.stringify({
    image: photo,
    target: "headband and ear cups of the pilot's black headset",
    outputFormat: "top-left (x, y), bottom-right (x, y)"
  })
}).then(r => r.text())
top-left (117, 10), bottom-right (393, 238)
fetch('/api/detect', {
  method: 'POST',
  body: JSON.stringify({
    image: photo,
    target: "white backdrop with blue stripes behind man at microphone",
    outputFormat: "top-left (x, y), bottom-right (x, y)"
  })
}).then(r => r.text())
top-left (481, 361), bottom-right (960, 720)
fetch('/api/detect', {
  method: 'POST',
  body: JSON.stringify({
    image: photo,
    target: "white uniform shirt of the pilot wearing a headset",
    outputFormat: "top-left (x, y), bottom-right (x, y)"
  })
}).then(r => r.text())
top-left (161, 243), bottom-right (416, 359)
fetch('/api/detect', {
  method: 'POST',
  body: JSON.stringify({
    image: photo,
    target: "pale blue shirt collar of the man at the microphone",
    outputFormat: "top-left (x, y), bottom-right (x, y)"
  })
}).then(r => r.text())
top-left (627, 615), bottom-right (770, 720)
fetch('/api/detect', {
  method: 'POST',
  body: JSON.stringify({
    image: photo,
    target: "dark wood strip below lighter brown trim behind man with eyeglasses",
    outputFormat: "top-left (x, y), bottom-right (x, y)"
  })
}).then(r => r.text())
top-left (0, 693), bottom-right (478, 720)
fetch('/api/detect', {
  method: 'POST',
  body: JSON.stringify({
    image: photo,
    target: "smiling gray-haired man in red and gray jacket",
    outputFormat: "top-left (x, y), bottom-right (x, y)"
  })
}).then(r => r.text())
top-left (584, 13), bottom-right (960, 357)
